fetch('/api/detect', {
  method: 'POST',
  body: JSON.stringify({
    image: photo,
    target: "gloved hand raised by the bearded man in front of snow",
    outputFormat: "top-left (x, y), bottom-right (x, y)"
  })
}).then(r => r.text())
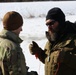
top-left (29, 41), bottom-right (40, 55)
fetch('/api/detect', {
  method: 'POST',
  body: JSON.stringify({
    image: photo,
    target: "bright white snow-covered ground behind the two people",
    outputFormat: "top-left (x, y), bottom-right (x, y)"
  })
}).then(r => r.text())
top-left (0, 1), bottom-right (76, 75)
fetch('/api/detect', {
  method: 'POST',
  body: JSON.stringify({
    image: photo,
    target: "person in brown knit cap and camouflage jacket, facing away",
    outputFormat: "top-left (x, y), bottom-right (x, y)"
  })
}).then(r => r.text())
top-left (0, 11), bottom-right (38, 75)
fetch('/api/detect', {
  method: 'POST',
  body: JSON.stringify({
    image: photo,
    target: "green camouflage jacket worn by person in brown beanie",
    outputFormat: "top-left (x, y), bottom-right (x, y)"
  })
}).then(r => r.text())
top-left (0, 29), bottom-right (27, 75)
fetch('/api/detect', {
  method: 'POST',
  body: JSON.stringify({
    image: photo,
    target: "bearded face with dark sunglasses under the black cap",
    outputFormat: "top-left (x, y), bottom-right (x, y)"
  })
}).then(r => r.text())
top-left (46, 20), bottom-right (59, 42)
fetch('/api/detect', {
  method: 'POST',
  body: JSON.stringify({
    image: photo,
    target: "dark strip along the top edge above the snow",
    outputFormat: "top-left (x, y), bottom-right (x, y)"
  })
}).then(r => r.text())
top-left (0, 0), bottom-right (75, 2)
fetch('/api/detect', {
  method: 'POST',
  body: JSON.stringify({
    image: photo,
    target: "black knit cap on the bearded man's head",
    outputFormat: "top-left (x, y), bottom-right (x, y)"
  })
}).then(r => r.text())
top-left (46, 7), bottom-right (65, 23)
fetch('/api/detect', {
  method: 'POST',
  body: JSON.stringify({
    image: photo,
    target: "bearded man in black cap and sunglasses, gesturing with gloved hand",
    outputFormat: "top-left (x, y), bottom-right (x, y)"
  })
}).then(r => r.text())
top-left (29, 7), bottom-right (76, 75)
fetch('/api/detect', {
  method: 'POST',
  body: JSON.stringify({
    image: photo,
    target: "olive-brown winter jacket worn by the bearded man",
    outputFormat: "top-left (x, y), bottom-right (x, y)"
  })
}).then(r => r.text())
top-left (38, 22), bottom-right (76, 75)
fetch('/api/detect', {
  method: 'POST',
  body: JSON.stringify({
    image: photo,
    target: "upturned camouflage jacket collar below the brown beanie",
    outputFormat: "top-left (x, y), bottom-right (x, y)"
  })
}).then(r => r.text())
top-left (0, 29), bottom-right (23, 43)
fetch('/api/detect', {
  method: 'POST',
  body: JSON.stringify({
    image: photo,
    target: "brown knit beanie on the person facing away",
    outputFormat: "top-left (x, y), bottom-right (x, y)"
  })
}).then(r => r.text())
top-left (3, 11), bottom-right (23, 31)
